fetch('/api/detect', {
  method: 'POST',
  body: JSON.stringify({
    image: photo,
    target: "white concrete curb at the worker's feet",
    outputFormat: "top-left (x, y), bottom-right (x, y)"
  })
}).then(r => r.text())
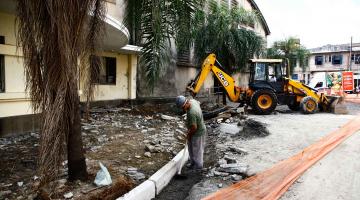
top-left (117, 148), bottom-right (189, 200)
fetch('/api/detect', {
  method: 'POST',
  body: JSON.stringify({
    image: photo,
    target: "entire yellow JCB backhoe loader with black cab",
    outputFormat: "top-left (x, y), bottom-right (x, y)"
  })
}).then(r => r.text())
top-left (187, 54), bottom-right (341, 114)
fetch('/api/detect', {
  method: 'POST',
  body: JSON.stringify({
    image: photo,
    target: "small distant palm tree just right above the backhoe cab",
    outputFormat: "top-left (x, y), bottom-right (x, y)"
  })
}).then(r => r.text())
top-left (267, 37), bottom-right (309, 74)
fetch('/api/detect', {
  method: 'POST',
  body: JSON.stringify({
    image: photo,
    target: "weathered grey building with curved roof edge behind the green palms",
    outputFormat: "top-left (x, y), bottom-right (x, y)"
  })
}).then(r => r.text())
top-left (138, 0), bottom-right (270, 97)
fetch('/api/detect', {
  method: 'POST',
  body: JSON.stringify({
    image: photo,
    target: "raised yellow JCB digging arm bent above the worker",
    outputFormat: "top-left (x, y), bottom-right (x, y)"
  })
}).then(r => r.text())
top-left (186, 54), bottom-right (241, 102)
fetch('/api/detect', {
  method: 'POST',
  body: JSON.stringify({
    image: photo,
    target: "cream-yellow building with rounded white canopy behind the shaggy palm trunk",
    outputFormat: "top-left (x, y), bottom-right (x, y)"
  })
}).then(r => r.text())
top-left (0, 0), bottom-right (140, 136)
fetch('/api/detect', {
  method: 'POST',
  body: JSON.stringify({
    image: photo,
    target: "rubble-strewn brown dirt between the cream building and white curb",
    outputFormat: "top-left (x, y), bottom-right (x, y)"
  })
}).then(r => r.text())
top-left (0, 105), bottom-right (186, 199)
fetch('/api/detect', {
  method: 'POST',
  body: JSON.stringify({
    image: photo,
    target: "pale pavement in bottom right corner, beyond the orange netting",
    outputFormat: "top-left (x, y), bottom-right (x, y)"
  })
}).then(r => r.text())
top-left (281, 132), bottom-right (360, 200)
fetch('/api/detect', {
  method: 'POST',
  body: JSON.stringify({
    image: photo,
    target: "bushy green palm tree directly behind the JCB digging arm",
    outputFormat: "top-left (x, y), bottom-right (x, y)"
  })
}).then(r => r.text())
top-left (192, 0), bottom-right (264, 72)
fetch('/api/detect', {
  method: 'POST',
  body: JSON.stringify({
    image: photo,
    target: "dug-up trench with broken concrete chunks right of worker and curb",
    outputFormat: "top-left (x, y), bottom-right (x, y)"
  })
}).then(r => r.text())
top-left (155, 115), bottom-right (270, 200)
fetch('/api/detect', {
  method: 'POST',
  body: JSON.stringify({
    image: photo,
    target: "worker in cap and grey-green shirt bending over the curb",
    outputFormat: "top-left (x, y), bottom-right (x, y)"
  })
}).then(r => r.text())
top-left (176, 96), bottom-right (206, 169)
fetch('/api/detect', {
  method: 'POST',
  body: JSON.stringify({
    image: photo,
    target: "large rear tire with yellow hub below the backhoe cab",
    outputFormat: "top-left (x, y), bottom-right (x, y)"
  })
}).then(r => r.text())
top-left (251, 89), bottom-right (277, 115)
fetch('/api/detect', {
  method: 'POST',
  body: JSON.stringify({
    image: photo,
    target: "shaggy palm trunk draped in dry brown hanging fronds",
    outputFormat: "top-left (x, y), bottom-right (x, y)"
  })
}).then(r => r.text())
top-left (17, 0), bottom-right (105, 186)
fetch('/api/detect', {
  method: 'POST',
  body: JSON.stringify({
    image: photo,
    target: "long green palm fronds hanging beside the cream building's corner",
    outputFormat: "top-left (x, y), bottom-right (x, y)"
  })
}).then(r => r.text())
top-left (125, 0), bottom-right (203, 90)
